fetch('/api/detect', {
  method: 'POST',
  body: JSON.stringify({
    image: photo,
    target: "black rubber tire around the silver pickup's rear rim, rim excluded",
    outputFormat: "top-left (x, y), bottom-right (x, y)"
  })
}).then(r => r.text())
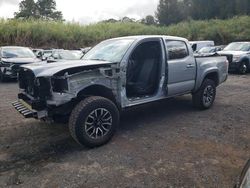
top-left (192, 79), bottom-right (216, 110)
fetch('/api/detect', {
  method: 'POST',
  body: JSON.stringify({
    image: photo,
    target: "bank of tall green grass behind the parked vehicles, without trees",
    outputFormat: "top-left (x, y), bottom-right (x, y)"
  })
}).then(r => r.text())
top-left (0, 16), bottom-right (250, 49)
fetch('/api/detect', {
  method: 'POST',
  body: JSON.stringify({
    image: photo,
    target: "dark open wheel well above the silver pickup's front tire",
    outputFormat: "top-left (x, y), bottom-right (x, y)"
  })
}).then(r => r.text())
top-left (77, 85), bottom-right (117, 105)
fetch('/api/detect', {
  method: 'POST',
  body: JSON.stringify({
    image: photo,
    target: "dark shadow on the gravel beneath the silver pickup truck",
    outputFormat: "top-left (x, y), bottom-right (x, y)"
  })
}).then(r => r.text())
top-left (0, 96), bottom-right (195, 173)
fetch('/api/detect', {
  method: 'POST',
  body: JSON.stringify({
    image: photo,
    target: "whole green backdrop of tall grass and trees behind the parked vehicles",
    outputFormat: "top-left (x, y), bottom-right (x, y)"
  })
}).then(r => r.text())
top-left (0, 0), bottom-right (250, 49)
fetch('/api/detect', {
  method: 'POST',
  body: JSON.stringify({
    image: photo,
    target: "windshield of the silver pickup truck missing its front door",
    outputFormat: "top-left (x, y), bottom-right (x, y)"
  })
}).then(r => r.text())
top-left (83, 39), bottom-right (134, 62)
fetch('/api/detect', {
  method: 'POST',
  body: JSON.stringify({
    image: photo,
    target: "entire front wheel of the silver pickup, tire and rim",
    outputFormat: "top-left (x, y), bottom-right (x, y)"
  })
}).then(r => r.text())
top-left (69, 97), bottom-right (119, 147)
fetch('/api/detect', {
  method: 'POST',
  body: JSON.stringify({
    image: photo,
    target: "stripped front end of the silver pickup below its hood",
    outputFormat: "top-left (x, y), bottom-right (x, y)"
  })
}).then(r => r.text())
top-left (13, 64), bottom-right (119, 120)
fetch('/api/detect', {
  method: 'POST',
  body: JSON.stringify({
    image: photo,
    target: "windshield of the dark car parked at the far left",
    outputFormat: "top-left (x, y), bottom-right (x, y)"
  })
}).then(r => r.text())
top-left (2, 47), bottom-right (35, 58)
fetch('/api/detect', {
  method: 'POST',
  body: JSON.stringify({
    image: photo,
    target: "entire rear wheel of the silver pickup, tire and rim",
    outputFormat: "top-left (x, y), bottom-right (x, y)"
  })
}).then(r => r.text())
top-left (193, 79), bottom-right (216, 110)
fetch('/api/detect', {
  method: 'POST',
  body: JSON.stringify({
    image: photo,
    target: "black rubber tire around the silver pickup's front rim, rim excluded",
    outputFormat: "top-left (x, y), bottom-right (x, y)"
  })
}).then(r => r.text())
top-left (69, 96), bottom-right (119, 148)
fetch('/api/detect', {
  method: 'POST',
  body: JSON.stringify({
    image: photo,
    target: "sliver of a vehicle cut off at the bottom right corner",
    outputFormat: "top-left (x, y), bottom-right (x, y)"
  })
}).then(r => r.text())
top-left (235, 160), bottom-right (250, 188)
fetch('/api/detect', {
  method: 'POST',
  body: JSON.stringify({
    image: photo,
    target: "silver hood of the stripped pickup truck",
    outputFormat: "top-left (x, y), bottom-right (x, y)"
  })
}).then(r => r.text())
top-left (22, 60), bottom-right (114, 77)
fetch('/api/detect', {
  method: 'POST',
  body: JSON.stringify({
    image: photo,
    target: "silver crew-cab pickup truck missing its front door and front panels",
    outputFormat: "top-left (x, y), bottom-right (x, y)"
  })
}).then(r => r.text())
top-left (13, 36), bottom-right (228, 147)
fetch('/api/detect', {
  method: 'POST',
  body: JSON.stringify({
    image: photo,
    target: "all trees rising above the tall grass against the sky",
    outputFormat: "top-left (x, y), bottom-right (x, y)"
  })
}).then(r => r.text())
top-left (15, 0), bottom-right (250, 25)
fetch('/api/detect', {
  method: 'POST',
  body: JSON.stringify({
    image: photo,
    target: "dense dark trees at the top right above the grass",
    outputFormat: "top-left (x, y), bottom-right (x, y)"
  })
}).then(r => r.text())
top-left (155, 0), bottom-right (250, 25)
